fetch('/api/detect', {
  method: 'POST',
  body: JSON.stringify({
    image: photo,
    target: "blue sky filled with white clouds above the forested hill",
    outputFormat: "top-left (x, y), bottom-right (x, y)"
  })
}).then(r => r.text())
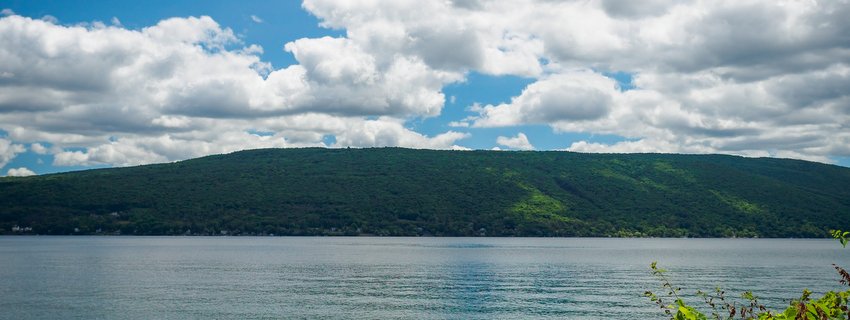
top-left (0, 0), bottom-right (850, 176)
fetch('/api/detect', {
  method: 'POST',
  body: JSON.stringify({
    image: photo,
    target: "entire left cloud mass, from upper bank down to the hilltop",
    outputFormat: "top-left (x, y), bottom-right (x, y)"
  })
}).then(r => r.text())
top-left (0, 12), bottom-right (467, 167)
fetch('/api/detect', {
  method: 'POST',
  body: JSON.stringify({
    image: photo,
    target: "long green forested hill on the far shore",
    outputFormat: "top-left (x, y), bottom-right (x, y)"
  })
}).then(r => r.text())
top-left (0, 148), bottom-right (850, 237)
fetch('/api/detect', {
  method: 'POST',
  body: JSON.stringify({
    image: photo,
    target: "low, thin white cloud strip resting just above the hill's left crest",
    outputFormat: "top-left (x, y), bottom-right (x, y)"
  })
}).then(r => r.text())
top-left (44, 114), bottom-right (468, 166)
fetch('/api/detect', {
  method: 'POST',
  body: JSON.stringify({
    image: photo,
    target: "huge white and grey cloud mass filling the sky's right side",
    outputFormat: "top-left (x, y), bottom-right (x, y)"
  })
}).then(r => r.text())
top-left (294, 0), bottom-right (850, 161)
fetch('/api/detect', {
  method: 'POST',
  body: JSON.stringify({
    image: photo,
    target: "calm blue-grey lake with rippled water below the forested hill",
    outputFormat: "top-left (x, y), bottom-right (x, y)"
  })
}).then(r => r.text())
top-left (0, 236), bottom-right (850, 319)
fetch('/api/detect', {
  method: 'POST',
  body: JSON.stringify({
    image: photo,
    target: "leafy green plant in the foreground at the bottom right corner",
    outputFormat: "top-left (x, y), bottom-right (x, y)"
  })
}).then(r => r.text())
top-left (644, 230), bottom-right (850, 320)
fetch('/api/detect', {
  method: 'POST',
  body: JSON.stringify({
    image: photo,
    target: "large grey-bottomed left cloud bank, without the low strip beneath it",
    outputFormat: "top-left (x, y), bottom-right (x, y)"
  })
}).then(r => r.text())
top-left (0, 16), bottom-right (462, 122)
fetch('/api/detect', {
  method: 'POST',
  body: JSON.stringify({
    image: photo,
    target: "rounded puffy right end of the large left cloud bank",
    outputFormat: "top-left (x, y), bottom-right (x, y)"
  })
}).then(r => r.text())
top-left (285, 37), bottom-right (462, 116)
